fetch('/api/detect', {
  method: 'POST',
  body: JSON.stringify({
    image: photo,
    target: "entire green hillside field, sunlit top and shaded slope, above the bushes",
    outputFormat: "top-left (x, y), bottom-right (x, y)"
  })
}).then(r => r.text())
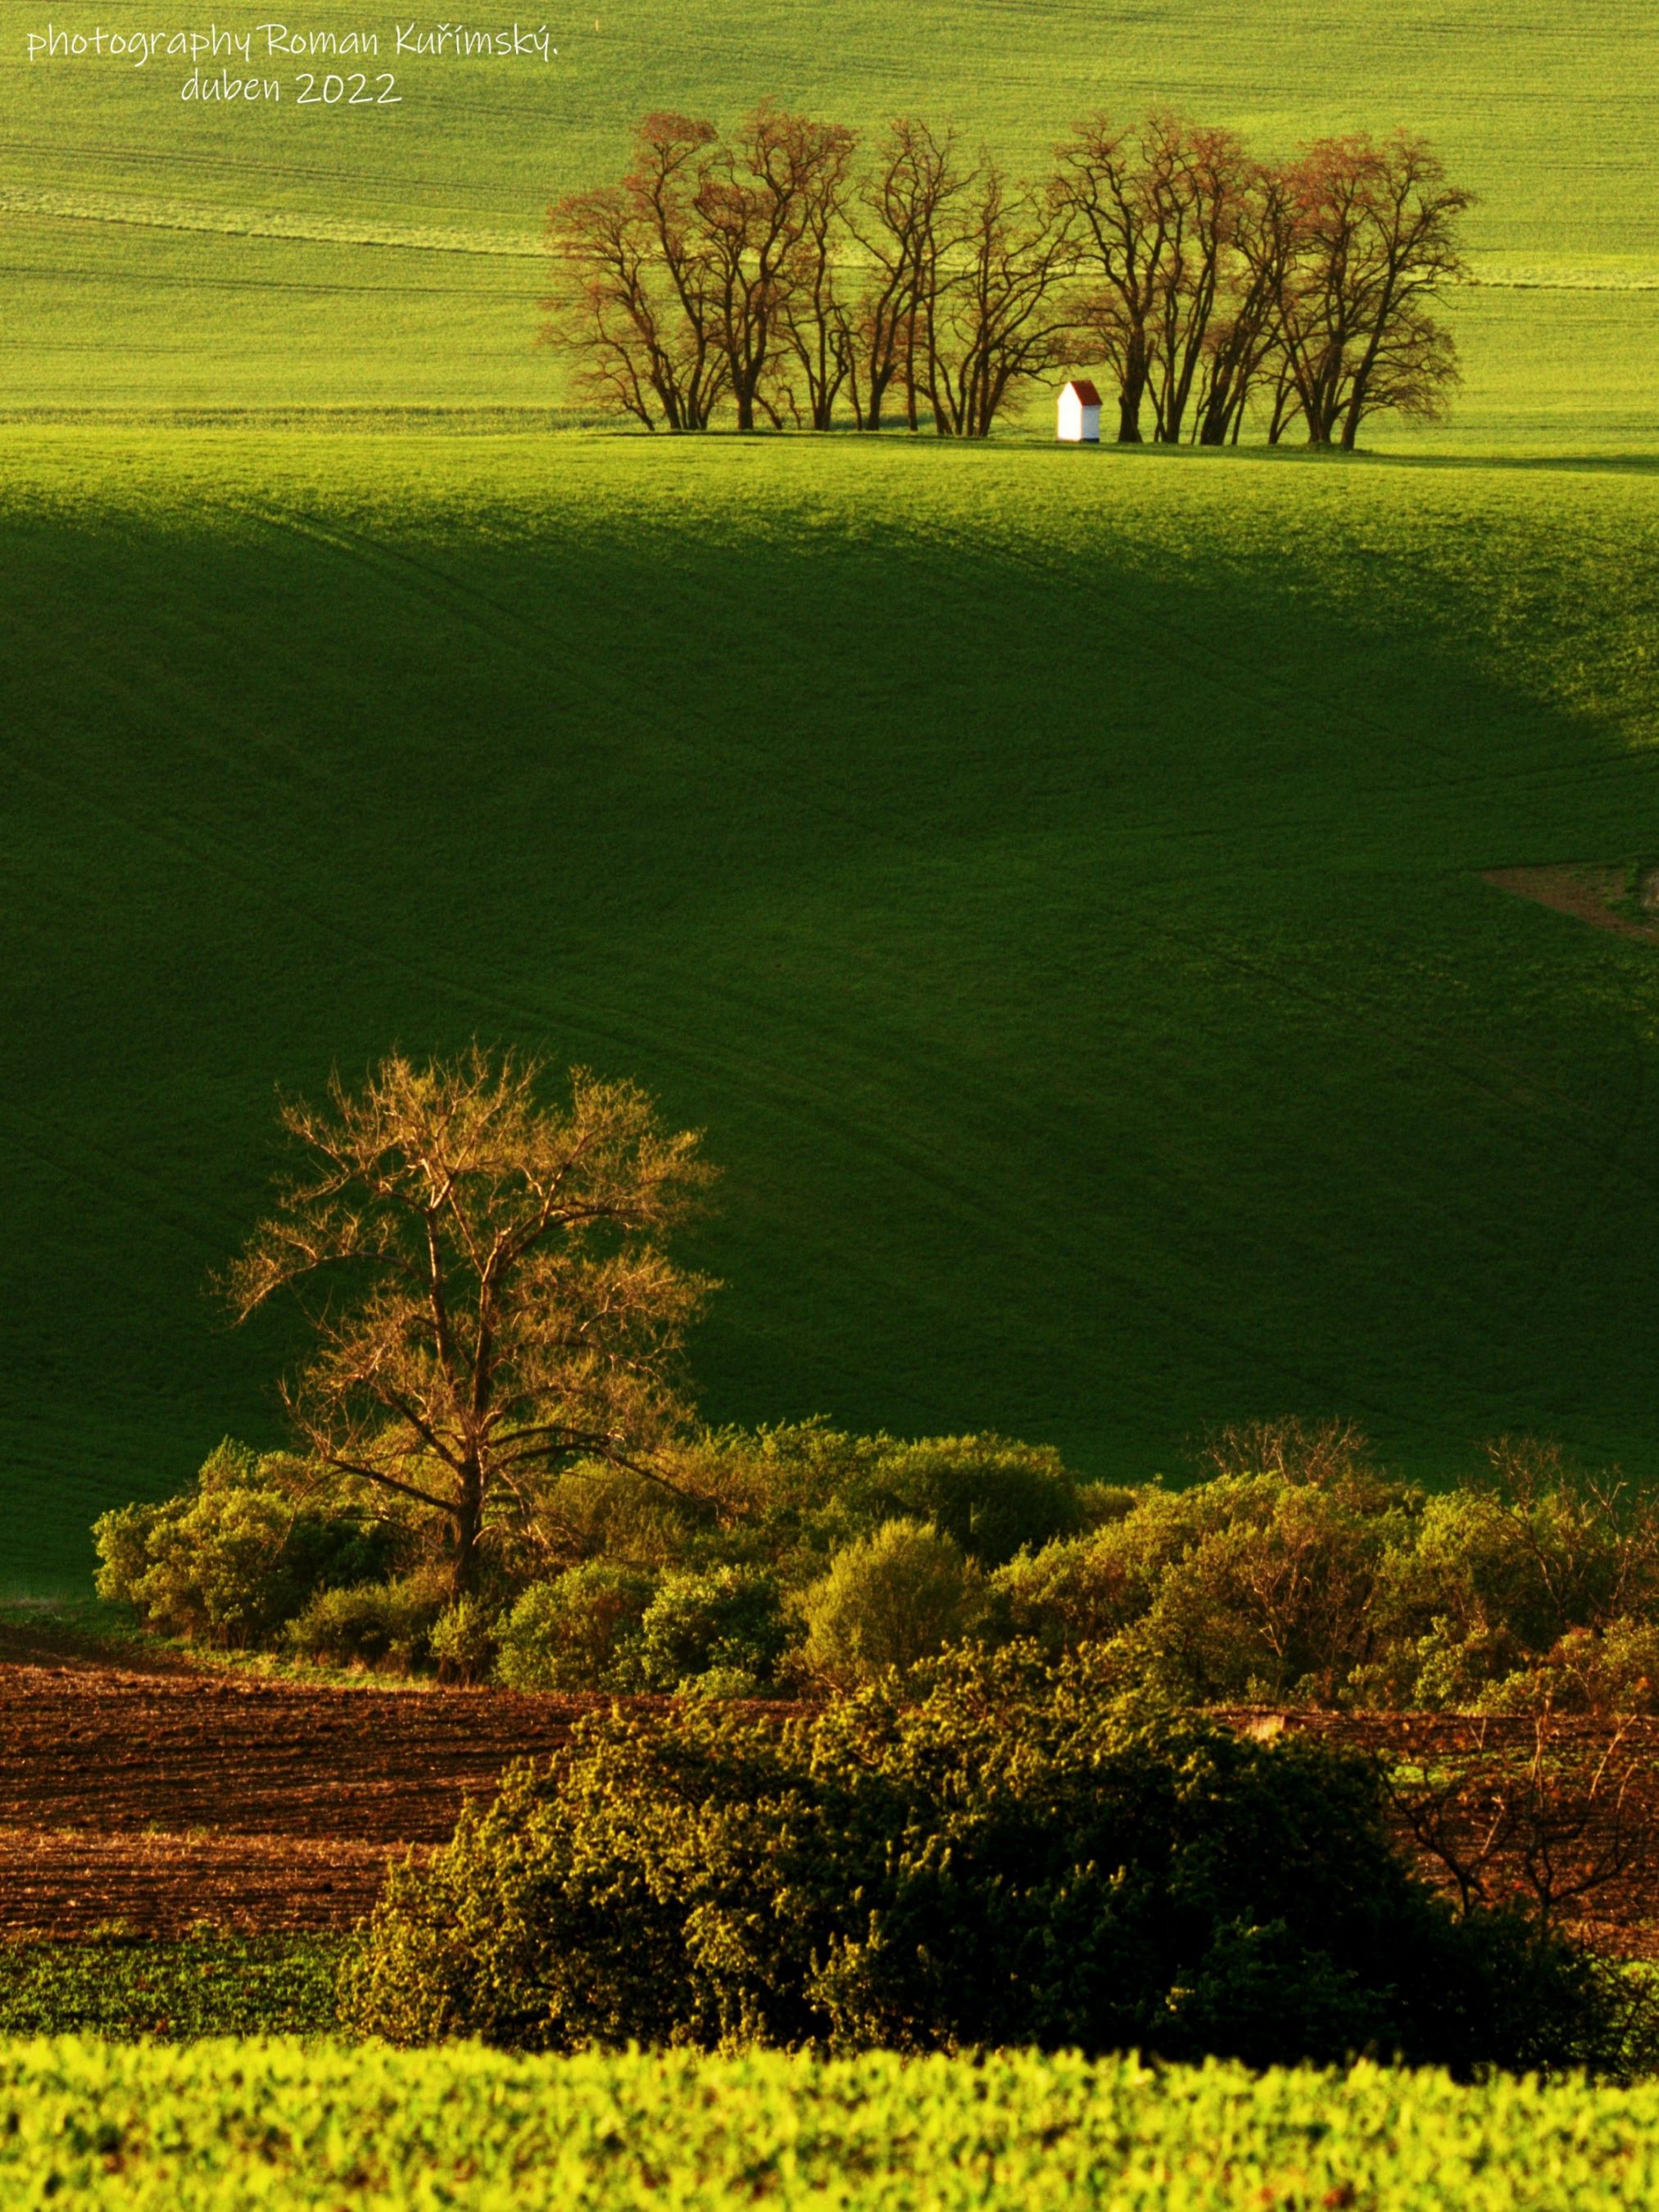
top-left (0, 0), bottom-right (1659, 1590)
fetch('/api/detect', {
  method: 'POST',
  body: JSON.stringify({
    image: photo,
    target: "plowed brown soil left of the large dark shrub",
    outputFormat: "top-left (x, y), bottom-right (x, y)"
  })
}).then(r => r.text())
top-left (0, 1659), bottom-right (672, 1936)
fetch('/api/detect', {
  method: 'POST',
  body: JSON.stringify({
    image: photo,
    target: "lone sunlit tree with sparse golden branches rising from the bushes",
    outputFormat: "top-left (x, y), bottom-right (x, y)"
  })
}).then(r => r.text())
top-left (224, 1046), bottom-right (712, 1597)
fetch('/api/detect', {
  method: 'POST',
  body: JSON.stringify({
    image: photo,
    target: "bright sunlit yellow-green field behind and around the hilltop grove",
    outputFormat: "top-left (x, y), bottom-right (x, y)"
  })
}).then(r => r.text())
top-left (0, 0), bottom-right (1659, 446)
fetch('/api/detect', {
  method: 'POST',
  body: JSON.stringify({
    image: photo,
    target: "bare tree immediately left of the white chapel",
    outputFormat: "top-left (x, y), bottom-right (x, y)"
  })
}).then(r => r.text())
top-left (925, 161), bottom-right (1077, 438)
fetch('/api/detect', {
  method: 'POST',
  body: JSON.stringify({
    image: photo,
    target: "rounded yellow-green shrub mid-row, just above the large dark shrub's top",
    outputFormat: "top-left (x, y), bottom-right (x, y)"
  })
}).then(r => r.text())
top-left (800, 1522), bottom-right (980, 1684)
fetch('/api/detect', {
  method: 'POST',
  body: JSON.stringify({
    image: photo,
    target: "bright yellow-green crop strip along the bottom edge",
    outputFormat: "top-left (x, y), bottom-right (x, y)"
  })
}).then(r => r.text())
top-left (0, 2039), bottom-right (1659, 2212)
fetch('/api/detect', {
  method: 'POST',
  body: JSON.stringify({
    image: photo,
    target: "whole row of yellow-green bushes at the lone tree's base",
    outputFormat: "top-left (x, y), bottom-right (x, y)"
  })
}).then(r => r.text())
top-left (97, 1422), bottom-right (1659, 1715)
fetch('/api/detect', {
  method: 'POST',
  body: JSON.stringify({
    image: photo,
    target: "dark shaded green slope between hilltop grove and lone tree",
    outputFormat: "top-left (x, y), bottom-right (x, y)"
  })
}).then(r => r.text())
top-left (0, 429), bottom-right (1659, 1590)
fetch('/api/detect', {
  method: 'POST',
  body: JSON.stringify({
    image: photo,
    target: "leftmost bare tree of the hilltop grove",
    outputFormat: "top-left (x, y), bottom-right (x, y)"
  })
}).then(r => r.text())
top-left (542, 115), bottom-right (728, 432)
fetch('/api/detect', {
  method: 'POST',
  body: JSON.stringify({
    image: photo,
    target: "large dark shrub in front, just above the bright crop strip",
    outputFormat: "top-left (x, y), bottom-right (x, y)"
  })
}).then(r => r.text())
top-left (341, 1648), bottom-right (1624, 2070)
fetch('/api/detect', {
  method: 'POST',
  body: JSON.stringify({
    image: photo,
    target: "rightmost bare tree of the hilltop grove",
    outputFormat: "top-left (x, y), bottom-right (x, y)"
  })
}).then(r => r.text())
top-left (1281, 130), bottom-right (1473, 451)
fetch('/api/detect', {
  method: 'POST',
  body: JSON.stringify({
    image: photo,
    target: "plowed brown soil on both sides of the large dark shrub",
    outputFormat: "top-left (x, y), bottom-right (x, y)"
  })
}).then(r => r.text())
top-left (0, 1657), bottom-right (1659, 1958)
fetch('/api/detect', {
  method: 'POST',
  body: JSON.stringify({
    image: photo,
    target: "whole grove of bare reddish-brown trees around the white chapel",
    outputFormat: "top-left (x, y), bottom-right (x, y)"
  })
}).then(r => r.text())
top-left (542, 104), bottom-right (1471, 449)
